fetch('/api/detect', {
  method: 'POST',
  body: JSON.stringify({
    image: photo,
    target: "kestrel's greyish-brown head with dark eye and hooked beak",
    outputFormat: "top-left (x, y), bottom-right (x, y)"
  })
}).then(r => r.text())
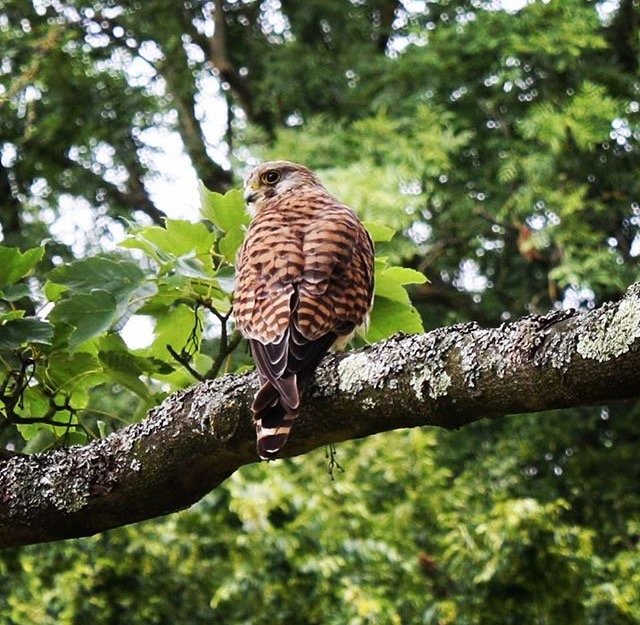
top-left (244, 161), bottom-right (320, 214)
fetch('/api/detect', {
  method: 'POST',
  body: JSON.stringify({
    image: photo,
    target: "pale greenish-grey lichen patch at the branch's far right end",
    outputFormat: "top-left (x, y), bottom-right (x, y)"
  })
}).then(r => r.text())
top-left (576, 298), bottom-right (640, 362)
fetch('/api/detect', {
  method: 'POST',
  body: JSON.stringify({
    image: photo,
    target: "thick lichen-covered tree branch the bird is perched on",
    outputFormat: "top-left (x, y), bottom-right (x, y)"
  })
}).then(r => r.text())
top-left (0, 283), bottom-right (640, 547)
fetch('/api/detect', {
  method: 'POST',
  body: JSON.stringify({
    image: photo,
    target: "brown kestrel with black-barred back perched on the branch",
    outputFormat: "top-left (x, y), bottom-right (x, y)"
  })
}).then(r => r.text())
top-left (233, 161), bottom-right (374, 460)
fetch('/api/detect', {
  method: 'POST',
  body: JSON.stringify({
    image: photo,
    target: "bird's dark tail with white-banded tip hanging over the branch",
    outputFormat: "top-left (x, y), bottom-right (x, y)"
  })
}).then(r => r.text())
top-left (251, 375), bottom-right (299, 460)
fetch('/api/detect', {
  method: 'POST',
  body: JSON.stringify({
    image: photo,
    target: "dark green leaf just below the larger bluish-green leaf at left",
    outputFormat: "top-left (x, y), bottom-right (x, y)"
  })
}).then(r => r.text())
top-left (49, 290), bottom-right (120, 348)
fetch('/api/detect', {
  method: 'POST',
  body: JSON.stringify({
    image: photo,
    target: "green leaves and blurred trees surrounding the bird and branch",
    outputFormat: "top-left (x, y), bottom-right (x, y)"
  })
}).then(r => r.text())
top-left (0, 0), bottom-right (640, 625)
